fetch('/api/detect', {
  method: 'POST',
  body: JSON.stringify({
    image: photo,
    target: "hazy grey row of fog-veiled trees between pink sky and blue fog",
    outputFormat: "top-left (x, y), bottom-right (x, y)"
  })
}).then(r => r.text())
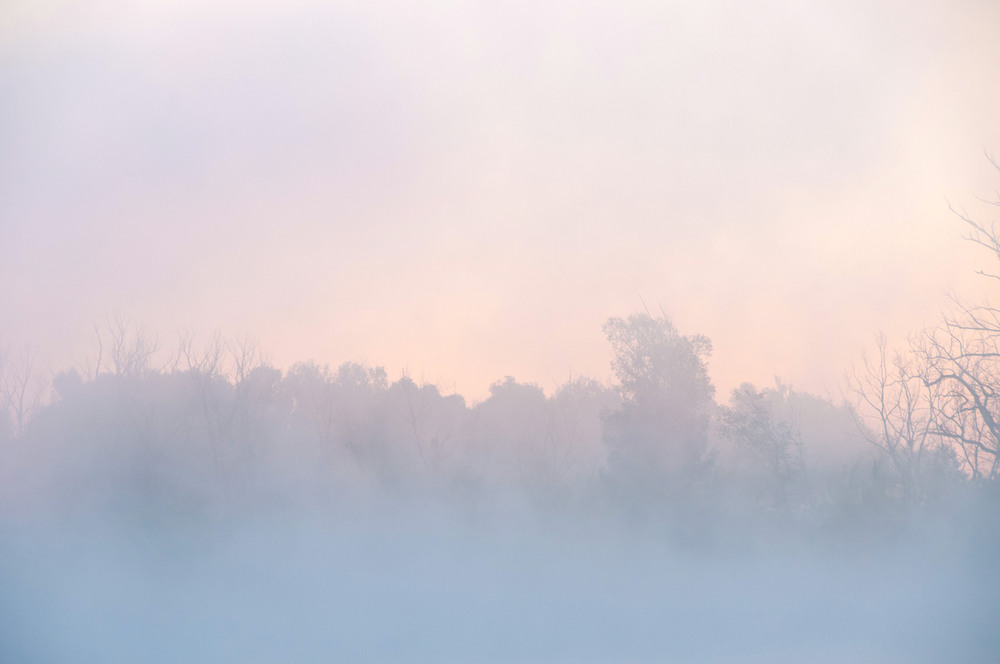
top-left (0, 163), bottom-right (1000, 540)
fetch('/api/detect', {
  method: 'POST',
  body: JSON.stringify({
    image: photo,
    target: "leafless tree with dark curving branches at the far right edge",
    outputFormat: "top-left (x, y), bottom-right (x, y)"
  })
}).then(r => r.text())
top-left (850, 154), bottom-right (1000, 488)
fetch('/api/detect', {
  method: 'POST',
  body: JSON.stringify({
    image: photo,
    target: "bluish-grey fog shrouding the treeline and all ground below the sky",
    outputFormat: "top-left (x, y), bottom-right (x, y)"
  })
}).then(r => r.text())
top-left (0, 313), bottom-right (1000, 662)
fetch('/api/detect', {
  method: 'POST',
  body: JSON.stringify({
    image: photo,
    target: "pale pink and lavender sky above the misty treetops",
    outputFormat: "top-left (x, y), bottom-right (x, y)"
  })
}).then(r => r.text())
top-left (0, 0), bottom-right (1000, 400)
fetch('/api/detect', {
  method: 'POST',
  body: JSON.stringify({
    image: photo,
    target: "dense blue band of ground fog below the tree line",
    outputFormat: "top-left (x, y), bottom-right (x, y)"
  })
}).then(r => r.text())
top-left (4, 506), bottom-right (997, 662)
